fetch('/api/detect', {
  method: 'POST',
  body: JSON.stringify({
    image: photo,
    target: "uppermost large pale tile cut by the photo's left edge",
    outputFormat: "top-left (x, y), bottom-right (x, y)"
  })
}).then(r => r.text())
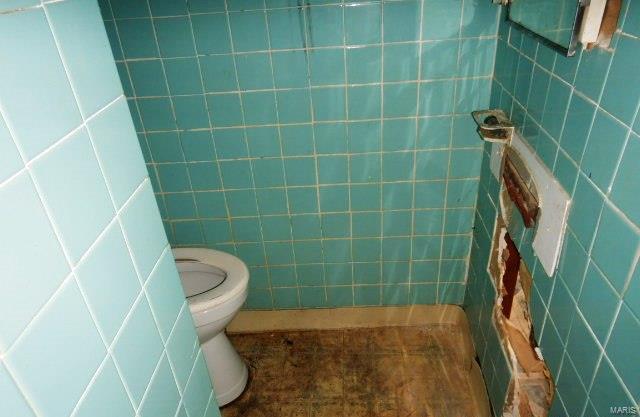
top-left (0, 8), bottom-right (81, 159)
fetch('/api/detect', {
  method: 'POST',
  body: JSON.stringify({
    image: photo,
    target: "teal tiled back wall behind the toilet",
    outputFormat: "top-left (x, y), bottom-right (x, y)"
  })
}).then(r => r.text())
top-left (103, 0), bottom-right (499, 309)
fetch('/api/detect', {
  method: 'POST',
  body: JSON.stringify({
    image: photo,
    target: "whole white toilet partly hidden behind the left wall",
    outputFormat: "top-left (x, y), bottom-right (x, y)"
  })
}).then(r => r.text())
top-left (173, 248), bottom-right (249, 406)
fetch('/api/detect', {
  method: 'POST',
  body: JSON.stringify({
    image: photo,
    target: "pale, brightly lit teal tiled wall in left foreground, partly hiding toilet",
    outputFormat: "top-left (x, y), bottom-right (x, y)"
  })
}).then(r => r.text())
top-left (0, 0), bottom-right (220, 417)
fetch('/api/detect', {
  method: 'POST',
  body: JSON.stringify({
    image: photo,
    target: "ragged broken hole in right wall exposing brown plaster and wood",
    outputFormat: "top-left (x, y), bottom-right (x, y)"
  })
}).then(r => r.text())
top-left (488, 148), bottom-right (554, 417)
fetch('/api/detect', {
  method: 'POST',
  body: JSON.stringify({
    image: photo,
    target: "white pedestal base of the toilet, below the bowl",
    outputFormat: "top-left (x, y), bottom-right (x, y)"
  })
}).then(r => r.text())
top-left (201, 331), bottom-right (249, 407)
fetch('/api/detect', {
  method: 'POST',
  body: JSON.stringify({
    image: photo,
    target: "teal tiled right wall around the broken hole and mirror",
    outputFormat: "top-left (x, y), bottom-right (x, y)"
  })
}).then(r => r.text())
top-left (465, 0), bottom-right (640, 417)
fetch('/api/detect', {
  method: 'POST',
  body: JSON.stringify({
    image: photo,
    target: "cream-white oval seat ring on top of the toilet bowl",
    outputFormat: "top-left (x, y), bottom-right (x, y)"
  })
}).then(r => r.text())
top-left (173, 248), bottom-right (249, 314)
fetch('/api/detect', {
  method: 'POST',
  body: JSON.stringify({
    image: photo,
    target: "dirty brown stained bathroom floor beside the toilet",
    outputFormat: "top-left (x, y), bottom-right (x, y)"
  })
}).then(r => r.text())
top-left (222, 325), bottom-right (476, 417)
